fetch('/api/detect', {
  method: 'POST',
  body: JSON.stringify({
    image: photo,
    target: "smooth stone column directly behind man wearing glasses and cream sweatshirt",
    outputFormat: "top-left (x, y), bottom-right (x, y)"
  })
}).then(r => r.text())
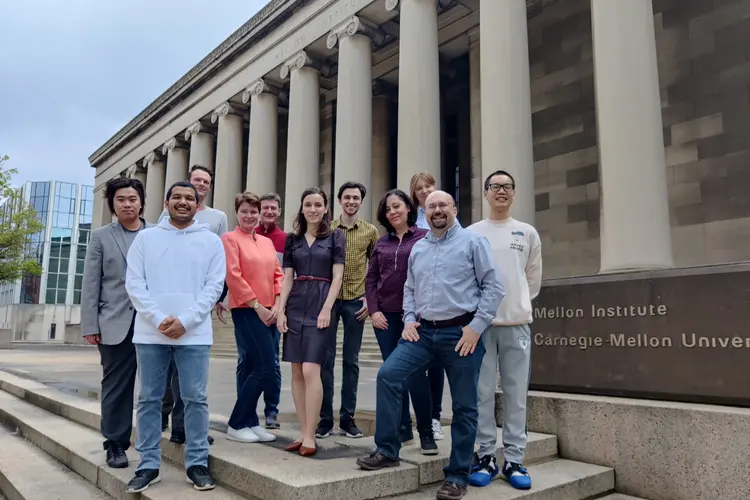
top-left (479, 0), bottom-right (536, 224)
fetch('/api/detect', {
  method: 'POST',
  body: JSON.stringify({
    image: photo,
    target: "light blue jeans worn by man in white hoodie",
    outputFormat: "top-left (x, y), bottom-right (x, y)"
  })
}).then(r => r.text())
top-left (135, 344), bottom-right (211, 470)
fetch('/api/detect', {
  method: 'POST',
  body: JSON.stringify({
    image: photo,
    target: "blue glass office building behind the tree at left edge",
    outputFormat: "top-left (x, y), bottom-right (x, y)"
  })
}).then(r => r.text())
top-left (0, 181), bottom-right (94, 306)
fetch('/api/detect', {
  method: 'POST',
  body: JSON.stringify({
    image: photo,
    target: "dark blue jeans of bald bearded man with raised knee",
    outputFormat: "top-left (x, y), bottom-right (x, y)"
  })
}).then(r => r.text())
top-left (375, 323), bottom-right (485, 485)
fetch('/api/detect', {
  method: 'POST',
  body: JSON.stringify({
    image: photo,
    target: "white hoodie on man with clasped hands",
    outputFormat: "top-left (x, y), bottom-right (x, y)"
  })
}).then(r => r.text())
top-left (125, 218), bottom-right (226, 345)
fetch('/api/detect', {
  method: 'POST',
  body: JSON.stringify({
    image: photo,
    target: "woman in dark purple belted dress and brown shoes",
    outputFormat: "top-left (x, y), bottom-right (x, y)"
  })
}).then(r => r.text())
top-left (277, 188), bottom-right (346, 456)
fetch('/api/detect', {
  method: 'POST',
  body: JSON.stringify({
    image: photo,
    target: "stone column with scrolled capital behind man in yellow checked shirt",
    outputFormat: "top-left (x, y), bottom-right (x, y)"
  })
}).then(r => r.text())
top-left (327, 16), bottom-right (382, 221)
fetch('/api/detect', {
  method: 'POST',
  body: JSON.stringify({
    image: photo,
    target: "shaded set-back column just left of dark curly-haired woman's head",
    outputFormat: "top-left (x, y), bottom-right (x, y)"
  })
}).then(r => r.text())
top-left (367, 95), bottom-right (393, 229)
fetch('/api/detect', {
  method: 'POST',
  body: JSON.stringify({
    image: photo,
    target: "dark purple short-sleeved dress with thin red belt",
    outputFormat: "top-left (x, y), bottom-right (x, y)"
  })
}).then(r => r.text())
top-left (281, 229), bottom-right (346, 364)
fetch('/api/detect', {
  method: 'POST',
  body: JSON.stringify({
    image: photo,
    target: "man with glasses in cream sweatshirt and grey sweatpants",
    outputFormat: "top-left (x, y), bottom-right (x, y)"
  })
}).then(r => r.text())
top-left (468, 170), bottom-right (542, 489)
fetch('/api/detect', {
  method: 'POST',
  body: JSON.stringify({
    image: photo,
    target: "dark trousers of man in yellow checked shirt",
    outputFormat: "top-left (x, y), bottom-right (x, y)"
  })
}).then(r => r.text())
top-left (320, 299), bottom-right (365, 425)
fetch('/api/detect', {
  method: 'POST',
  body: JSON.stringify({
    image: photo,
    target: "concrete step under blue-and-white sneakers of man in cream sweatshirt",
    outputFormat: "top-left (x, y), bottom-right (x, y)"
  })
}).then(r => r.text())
top-left (394, 459), bottom-right (615, 500)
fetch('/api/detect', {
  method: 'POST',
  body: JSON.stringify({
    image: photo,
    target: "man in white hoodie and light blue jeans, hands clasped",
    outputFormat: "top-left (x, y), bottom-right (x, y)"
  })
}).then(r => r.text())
top-left (125, 181), bottom-right (226, 493)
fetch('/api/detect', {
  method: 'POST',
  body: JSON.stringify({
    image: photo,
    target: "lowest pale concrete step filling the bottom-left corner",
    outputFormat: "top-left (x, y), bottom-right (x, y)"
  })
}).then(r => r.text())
top-left (0, 427), bottom-right (112, 500)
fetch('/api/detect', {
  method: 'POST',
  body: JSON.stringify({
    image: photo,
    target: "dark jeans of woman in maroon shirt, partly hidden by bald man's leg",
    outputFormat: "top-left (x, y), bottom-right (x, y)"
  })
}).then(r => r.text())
top-left (374, 312), bottom-right (432, 436)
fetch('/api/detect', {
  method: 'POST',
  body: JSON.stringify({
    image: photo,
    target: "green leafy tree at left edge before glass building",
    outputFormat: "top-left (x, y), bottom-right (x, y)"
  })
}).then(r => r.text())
top-left (0, 156), bottom-right (42, 284)
